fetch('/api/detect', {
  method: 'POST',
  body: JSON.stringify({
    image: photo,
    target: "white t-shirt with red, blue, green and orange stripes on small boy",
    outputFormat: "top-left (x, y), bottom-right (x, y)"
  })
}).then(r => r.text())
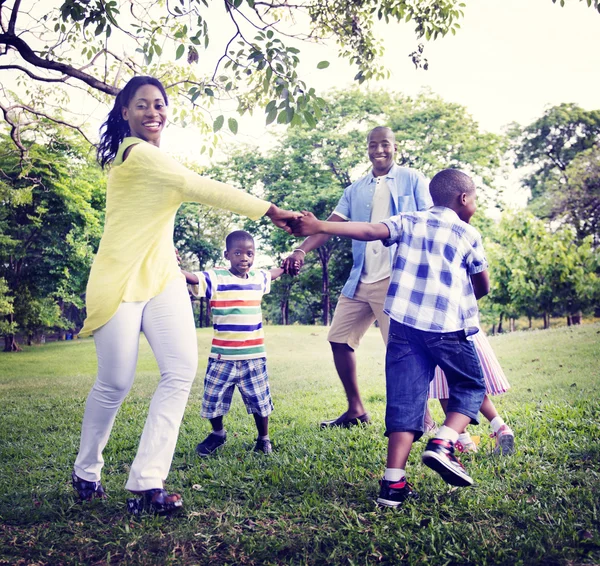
top-left (192, 268), bottom-right (271, 360)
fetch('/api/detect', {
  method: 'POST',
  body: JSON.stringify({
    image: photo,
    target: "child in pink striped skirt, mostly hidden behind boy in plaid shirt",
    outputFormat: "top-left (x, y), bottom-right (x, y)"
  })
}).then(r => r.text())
top-left (429, 330), bottom-right (515, 455)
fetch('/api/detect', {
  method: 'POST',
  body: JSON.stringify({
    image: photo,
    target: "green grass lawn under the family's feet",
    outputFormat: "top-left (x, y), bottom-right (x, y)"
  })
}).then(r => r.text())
top-left (0, 324), bottom-right (600, 566)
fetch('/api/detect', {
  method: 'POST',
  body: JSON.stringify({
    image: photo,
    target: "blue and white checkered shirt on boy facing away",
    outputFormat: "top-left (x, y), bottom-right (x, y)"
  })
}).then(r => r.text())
top-left (383, 206), bottom-right (488, 335)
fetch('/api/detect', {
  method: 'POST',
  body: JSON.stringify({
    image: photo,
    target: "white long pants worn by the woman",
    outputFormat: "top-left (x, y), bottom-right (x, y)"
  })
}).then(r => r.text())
top-left (75, 279), bottom-right (198, 491)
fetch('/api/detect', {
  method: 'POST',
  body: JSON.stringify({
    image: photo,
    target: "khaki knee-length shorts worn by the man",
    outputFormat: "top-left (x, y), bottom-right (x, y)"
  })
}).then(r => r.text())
top-left (327, 277), bottom-right (390, 350)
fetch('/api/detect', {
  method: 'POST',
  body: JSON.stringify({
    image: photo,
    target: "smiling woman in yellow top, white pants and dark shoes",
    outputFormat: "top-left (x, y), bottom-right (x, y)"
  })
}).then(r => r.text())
top-left (72, 77), bottom-right (300, 513)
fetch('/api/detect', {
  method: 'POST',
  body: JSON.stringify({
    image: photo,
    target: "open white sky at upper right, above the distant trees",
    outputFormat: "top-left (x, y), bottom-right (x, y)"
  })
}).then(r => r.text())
top-left (165, 0), bottom-right (600, 209)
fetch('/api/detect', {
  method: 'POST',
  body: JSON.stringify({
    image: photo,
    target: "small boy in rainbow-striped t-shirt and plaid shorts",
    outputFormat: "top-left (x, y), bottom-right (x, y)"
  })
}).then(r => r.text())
top-left (183, 230), bottom-right (283, 456)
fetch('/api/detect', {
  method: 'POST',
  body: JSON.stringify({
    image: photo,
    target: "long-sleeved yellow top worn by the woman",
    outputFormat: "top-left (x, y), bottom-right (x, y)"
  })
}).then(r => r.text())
top-left (79, 138), bottom-right (270, 336)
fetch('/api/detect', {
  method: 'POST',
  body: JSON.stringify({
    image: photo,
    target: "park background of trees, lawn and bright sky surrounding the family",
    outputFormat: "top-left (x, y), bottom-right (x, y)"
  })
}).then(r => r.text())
top-left (0, 0), bottom-right (600, 565)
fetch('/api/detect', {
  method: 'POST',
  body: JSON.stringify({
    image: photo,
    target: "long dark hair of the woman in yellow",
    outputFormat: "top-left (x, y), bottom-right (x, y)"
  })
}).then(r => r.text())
top-left (96, 76), bottom-right (169, 168)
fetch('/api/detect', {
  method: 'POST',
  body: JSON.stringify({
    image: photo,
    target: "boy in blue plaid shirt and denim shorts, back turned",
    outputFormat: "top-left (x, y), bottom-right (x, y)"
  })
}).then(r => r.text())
top-left (293, 169), bottom-right (489, 507)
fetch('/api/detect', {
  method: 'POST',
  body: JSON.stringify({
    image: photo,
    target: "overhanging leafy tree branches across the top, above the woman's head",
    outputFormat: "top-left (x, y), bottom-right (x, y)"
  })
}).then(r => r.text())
top-left (0, 0), bottom-right (598, 160)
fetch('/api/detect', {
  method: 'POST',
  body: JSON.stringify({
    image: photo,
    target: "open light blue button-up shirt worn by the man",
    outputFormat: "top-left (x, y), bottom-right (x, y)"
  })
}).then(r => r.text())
top-left (333, 164), bottom-right (433, 299)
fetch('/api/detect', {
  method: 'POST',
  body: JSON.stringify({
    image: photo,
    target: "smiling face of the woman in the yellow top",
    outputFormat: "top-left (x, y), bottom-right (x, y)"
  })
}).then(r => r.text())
top-left (121, 85), bottom-right (167, 147)
